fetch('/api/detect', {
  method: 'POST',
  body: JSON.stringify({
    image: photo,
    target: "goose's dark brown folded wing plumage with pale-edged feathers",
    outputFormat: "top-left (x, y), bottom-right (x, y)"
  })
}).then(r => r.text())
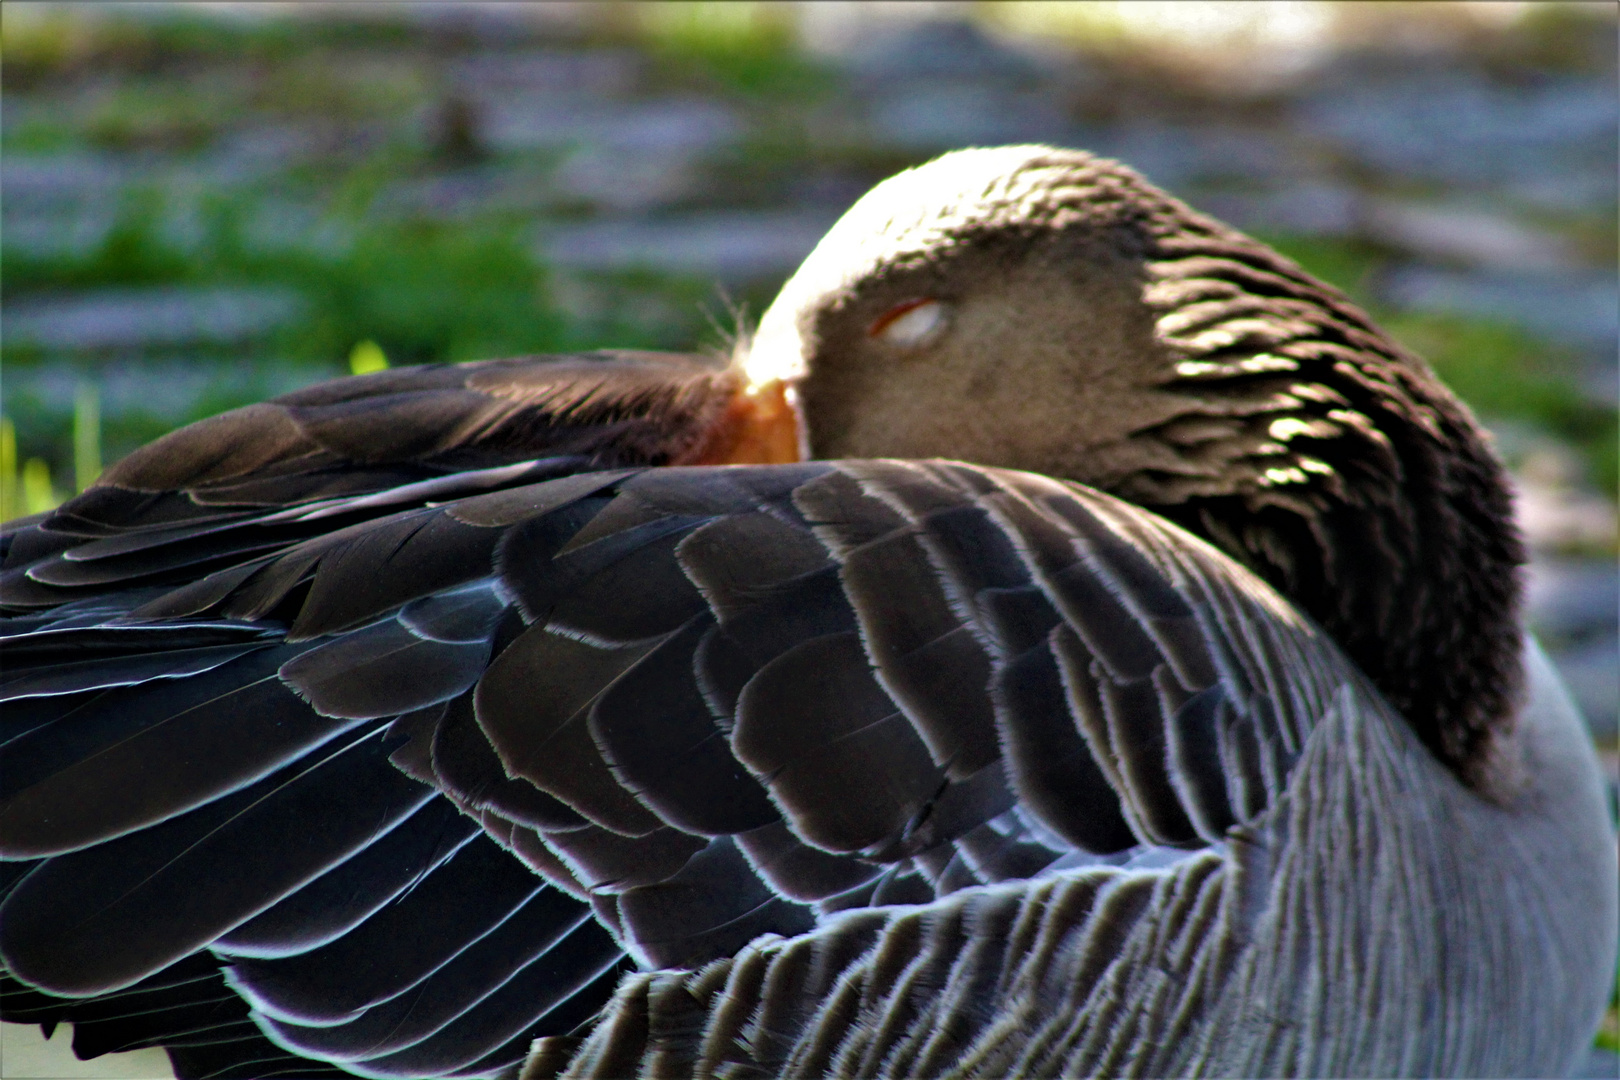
top-left (0, 359), bottom-right (1332, 1077)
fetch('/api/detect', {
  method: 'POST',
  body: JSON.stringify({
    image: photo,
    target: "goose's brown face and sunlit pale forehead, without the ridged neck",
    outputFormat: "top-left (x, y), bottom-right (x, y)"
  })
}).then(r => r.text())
top-left (748, 146), bottom-right (1175, 481)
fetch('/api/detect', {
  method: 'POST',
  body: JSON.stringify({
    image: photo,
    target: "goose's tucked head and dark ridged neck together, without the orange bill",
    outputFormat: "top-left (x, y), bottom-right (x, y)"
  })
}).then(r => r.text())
top-left (744, 146), bottom-right (1523, 784)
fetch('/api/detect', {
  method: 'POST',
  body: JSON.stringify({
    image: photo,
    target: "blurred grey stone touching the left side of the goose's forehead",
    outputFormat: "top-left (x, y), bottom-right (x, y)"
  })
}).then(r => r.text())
top-left (539, 212), bottom-right (836, 282)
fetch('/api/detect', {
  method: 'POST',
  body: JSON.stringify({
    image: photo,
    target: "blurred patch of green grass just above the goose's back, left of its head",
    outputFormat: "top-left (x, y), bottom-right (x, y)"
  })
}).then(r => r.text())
top-left (0, 170), bottom-right (732, 495)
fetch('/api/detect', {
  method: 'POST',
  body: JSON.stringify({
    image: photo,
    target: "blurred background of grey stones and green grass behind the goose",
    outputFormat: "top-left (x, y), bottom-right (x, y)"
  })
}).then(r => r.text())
top-left (0, 0), bottom-right (1620, 1068)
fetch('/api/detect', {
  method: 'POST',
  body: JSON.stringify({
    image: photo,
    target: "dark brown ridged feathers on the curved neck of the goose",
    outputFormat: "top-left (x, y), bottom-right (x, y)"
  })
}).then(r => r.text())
top-left (1119, 213), bottom-right (1524, 782)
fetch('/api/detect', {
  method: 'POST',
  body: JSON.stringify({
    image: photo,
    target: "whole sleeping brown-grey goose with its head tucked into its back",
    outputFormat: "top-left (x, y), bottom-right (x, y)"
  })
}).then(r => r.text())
top-left (0, 146), bottom-right (1620, 1080)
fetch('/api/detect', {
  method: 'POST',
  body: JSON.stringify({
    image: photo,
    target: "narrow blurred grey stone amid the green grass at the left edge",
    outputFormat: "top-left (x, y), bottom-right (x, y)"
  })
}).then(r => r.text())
top-left (0, 287), bottom-right (303, 351)
